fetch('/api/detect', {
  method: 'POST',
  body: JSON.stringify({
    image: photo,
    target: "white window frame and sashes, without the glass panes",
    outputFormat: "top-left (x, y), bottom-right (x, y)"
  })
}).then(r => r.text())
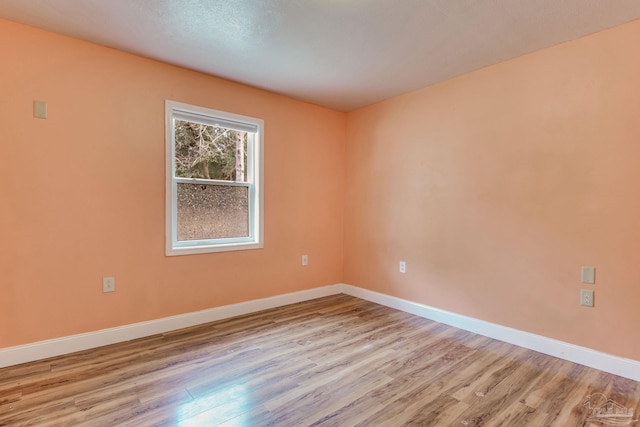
top-left (165, 100), bottom-right (264, 256)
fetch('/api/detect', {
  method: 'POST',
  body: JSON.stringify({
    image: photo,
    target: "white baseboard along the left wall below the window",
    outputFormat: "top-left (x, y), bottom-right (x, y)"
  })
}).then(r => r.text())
top-left (0, 285), bottom-right (341, 368)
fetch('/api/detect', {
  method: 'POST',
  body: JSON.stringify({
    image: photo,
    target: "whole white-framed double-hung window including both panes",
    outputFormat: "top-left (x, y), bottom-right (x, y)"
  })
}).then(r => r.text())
top-left (165, 101), bottom-right (264, 255)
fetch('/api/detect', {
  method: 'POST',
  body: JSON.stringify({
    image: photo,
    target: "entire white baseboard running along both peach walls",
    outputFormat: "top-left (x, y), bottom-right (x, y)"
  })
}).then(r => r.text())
top-left (0, 284), bottom-right (640, 381)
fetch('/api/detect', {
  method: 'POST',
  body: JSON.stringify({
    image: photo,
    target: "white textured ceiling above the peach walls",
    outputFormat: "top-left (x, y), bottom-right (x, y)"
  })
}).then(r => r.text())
top-left (0, 0), bottom-right (640, 111)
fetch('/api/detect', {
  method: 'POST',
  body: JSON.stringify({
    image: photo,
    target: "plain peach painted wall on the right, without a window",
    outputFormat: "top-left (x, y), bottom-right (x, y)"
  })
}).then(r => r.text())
top-left (345, 21), bottom-right (640, 360)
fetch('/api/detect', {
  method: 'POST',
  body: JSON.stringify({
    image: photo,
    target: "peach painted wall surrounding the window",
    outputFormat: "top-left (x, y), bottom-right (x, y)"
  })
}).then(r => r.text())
top-left (0, 20), bottom-right (346, 348)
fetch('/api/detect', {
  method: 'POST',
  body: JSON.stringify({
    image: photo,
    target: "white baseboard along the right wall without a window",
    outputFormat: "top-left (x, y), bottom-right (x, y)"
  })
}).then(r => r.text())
top-left (341, 285), bottom-right (640, 381)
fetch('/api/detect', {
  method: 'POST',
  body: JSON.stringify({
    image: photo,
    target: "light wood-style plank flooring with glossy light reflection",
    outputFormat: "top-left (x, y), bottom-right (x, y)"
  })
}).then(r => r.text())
top-left (0, 295), bottom-right (640, 427)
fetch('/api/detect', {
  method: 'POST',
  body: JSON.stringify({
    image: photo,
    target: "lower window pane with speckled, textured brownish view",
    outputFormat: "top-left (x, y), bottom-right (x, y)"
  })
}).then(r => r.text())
top-left (178, 183), bottom-right (249, 241)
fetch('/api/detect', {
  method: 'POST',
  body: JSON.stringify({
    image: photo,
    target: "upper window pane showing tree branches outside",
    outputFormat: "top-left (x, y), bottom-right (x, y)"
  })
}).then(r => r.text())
top-left (174, 119), bottom-right (248, 182)
